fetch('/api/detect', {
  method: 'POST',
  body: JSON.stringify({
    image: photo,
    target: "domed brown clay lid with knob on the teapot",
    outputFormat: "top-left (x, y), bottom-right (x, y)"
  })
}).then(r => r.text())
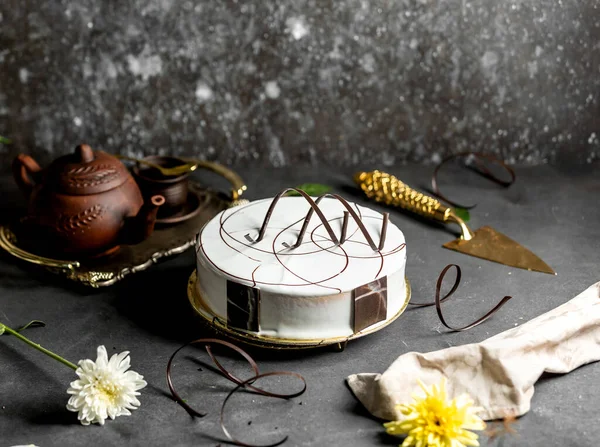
top-left (46, 144), bottom-right (130, 195)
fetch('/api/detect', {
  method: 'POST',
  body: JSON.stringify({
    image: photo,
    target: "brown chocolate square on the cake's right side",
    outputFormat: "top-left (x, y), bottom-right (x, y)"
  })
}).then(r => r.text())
top-left (352, 276), bottom-right (387, 332)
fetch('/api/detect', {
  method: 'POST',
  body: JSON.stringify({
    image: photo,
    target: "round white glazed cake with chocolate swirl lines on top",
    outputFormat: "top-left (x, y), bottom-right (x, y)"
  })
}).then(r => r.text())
top-left (196, 196), bottom-right (407, 340)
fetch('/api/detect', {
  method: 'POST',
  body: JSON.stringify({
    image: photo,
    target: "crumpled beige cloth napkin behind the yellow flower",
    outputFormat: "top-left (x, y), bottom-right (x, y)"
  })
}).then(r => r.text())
top-left (348, 282), bottom-right (600, 420)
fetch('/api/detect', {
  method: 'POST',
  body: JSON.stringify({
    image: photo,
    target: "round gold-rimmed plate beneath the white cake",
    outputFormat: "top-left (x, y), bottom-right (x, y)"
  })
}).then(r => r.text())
top-left (188, 271), bottom-right (411, 351)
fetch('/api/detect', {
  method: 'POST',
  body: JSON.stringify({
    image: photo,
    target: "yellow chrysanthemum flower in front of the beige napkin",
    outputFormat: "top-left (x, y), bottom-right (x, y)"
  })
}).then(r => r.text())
top-left (383, 378), bottom-right (485, 447)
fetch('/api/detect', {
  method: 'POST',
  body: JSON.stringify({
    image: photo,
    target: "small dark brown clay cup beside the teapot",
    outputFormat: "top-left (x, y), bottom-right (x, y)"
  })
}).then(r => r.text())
top-left (133, 155), bottom-right (189, 218)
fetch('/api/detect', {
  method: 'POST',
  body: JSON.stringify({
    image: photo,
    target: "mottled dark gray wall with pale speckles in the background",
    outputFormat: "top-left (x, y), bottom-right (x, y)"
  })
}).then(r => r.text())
top-left (0, 0), bottom-right (600, 166)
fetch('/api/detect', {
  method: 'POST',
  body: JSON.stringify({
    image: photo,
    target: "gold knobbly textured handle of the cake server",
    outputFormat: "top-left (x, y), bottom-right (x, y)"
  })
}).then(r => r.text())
top-left (354, 171), bottom-right (473, 240)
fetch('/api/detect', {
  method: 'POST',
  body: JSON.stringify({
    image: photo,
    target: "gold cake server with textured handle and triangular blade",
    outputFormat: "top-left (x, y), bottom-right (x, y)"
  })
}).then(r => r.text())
top-left (354, 171), bottom-right (556, 274)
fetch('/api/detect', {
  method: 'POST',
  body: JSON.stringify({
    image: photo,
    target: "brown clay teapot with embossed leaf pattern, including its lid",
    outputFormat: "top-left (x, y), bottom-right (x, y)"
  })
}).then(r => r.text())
top-left (13, 144), bottom-right (165, 257)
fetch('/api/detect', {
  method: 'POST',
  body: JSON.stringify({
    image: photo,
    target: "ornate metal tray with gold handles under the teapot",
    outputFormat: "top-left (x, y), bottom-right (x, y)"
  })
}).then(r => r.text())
top-left (0, 162), bottom-right (246, 287)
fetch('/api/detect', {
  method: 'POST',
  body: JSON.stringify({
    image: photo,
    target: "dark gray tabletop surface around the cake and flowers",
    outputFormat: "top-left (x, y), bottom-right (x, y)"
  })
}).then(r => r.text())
top-left (0, 164), bottom-right (600, 447)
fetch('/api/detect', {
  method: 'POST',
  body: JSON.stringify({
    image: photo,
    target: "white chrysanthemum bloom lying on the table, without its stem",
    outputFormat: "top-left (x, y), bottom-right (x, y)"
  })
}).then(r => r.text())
top-left (67, 346), bottom-right (147, 425)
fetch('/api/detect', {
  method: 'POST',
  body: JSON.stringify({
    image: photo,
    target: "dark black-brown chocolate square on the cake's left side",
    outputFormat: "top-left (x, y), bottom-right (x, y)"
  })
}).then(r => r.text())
top-left (227, 281), bottom-right (260, 332)
